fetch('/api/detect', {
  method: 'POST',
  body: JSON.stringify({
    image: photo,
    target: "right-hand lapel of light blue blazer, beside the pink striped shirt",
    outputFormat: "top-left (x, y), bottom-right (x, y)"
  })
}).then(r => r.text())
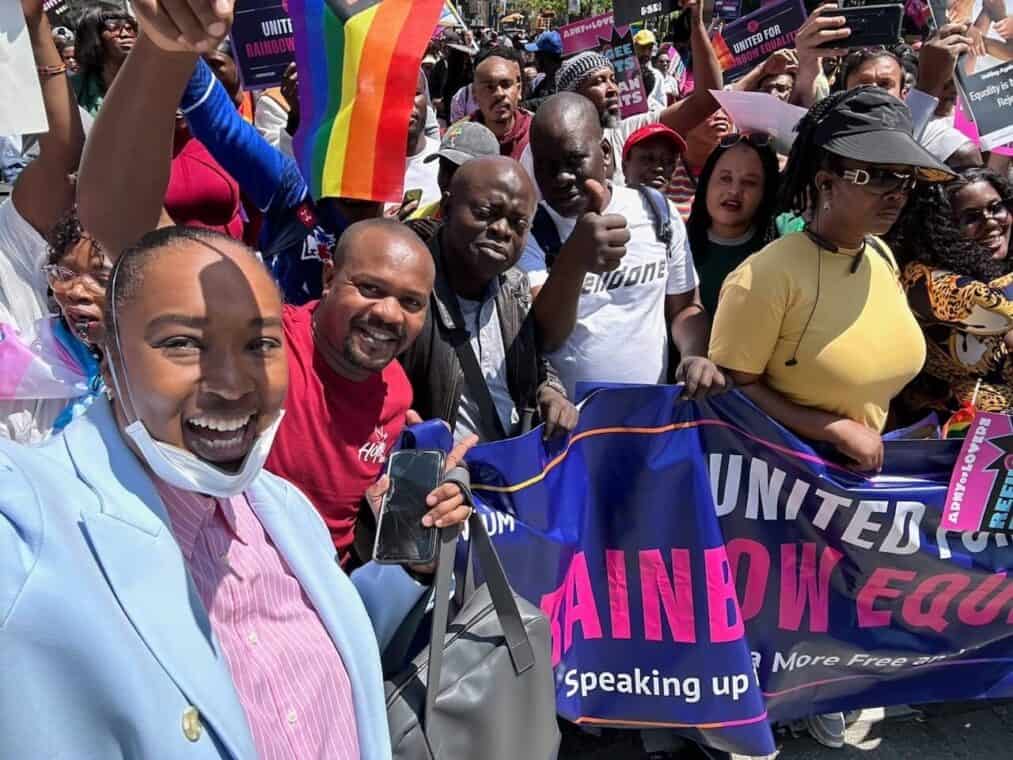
top-left (247, 478), bottom-right (390, 760)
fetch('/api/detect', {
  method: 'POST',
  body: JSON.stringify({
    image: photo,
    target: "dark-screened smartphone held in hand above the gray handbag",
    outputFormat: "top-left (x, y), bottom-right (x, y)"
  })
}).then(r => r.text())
top-left (373, 449), bottom-right (446, 564)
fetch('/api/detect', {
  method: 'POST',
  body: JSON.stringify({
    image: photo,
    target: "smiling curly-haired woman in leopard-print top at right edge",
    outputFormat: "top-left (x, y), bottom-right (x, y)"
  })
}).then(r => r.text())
top-left (893, 168), bottom-right (1013, 414)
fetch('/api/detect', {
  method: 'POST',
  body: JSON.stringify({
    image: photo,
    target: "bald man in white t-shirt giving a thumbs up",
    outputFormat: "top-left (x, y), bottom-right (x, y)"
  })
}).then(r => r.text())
top-left (520, 93), bottom-right (725, 398)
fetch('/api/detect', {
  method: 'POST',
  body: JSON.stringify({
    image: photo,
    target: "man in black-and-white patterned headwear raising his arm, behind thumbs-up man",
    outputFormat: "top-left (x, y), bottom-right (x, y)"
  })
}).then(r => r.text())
top-left (551, 1), bottom-right (723, 184)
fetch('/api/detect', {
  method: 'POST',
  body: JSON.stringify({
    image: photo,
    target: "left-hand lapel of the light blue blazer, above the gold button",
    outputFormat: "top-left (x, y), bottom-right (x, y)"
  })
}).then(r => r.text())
top-left (64, 399), bottom-right (256, 760)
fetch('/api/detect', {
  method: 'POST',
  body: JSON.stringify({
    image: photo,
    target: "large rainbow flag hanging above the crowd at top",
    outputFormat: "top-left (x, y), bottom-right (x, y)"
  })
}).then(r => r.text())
top-left (288, 0), bottom-right (444, 202)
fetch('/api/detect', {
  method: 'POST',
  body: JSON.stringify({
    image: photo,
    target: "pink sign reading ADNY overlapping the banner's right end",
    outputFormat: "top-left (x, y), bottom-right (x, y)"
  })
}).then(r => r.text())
top-left (943, 411), bottom-right (1013, 533)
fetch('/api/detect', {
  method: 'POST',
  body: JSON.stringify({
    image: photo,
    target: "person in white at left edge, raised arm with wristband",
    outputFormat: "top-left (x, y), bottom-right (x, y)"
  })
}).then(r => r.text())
top-left (0, 3), bottom-right (84, 444)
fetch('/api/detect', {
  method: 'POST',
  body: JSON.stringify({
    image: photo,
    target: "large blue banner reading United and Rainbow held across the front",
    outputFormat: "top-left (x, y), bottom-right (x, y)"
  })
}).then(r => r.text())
top-left (449, 387), bottom-right (1013, 755)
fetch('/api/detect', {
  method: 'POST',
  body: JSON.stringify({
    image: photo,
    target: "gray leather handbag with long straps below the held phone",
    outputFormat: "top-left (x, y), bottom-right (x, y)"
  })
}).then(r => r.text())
top-left (385, 472), bottom-right (559, 760)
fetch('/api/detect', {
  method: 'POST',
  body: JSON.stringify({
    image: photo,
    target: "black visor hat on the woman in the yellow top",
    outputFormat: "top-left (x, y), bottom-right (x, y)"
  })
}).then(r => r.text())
top-left (813, 86), bottom-right (956, 182)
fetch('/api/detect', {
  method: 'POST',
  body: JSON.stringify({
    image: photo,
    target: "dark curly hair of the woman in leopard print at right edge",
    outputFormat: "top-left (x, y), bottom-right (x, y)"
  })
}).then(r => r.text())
top-left (886, 167), bottom-right (1013, 283)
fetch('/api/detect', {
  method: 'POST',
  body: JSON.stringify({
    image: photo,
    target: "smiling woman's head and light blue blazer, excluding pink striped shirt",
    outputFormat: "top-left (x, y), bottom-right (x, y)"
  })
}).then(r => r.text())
top-left (0, 228), bottom-right (470, 760)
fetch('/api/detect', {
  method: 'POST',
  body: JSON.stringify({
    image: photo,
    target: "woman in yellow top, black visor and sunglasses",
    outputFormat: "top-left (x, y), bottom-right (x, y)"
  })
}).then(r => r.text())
top-left (710, 87), bottom-right (952, 470)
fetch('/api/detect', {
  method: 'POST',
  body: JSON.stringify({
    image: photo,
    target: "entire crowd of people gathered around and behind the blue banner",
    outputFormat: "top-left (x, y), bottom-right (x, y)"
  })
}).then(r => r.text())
top-left (0, 0), bottom-right (1013, 758)
